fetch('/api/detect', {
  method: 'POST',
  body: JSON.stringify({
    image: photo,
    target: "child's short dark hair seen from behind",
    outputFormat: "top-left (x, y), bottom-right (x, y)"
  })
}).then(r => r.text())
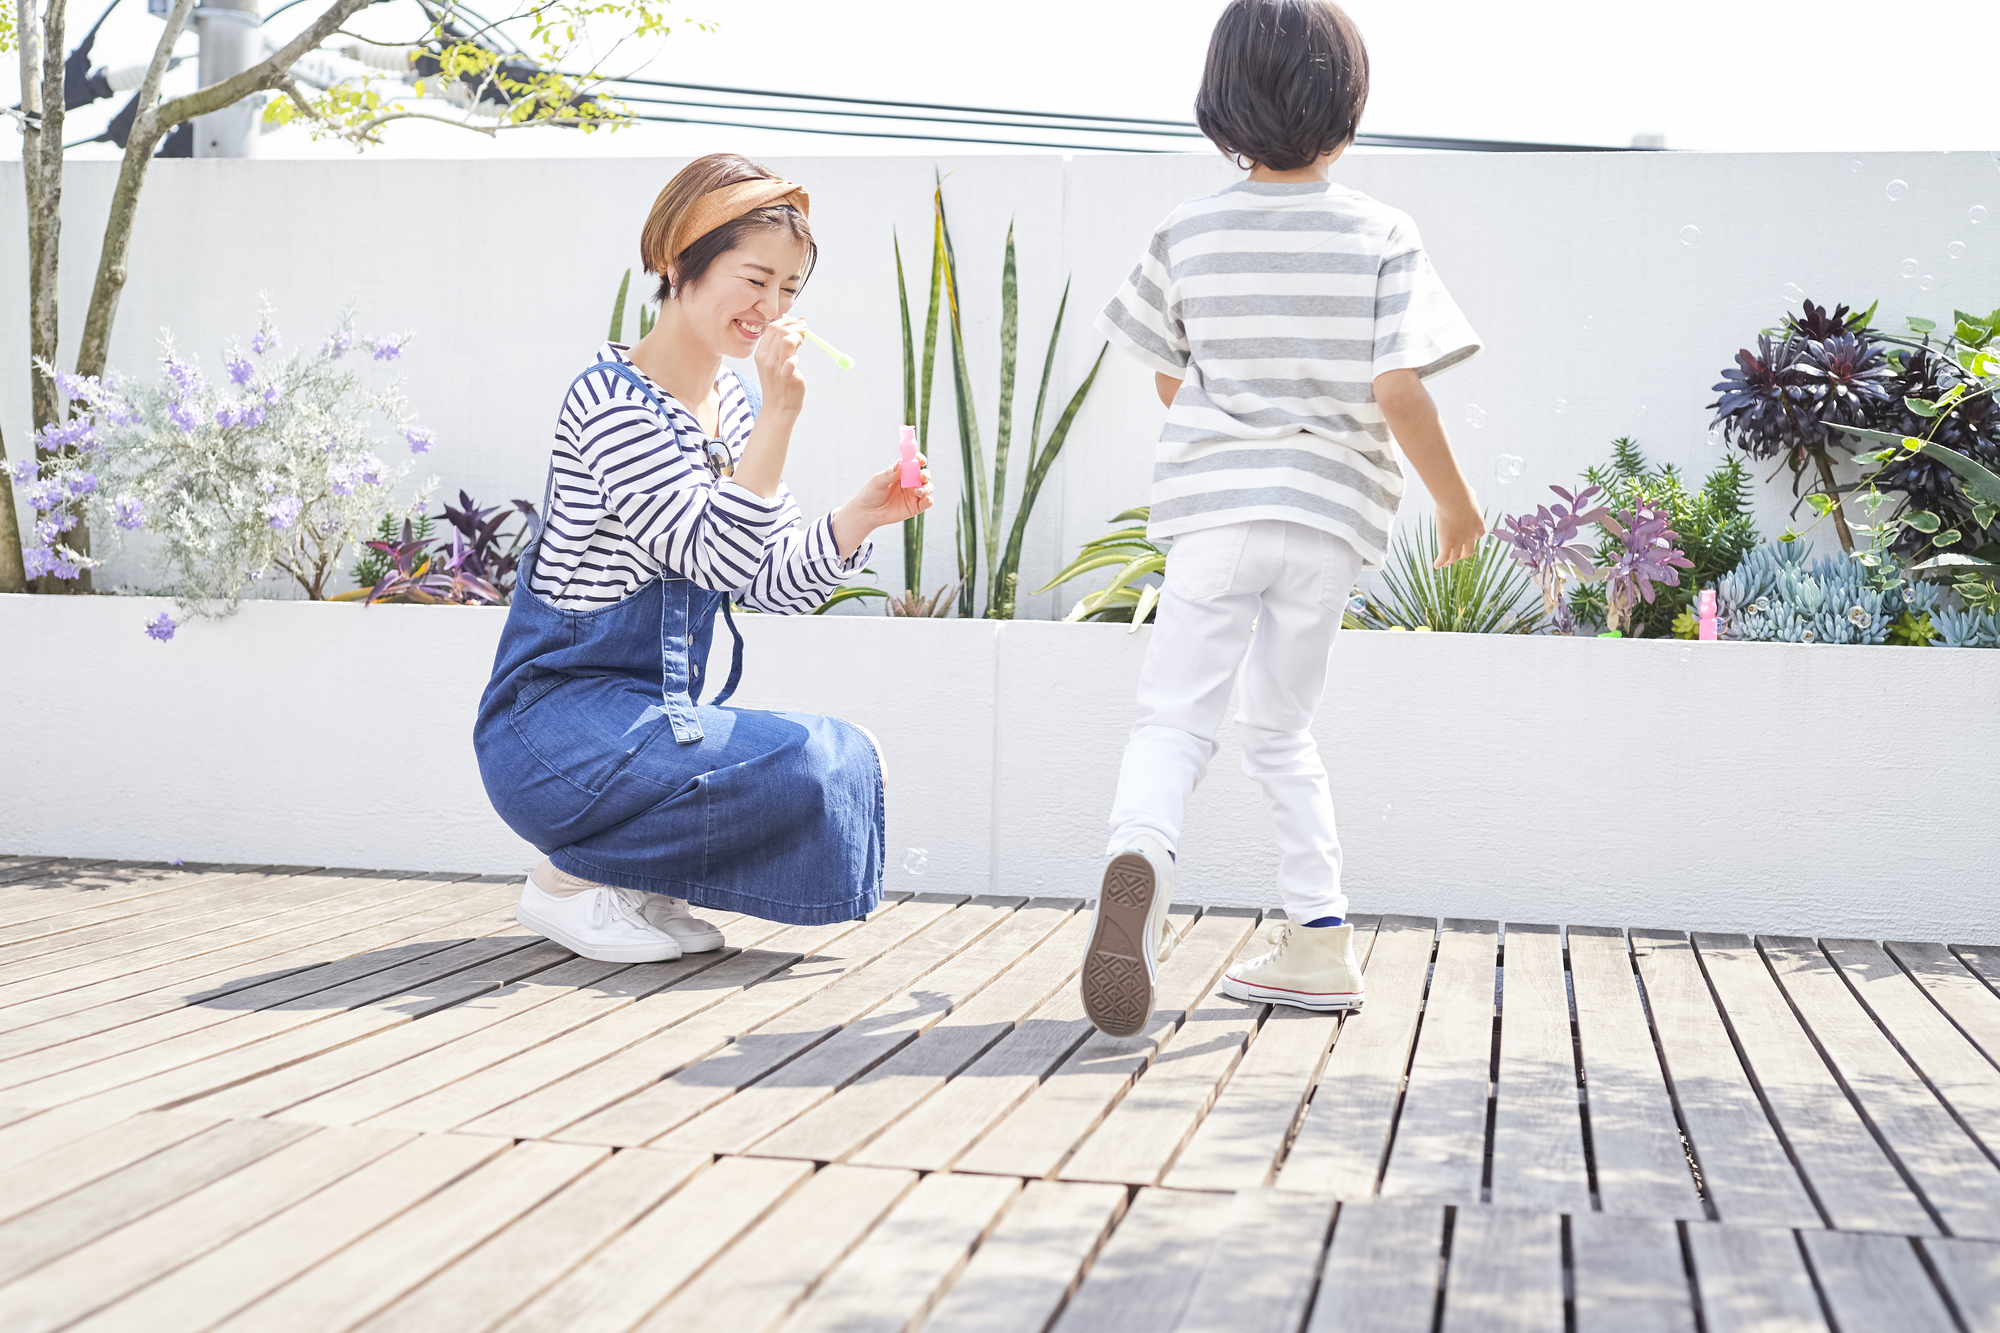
top-left (1194, 0), bottom-right (1368, 172)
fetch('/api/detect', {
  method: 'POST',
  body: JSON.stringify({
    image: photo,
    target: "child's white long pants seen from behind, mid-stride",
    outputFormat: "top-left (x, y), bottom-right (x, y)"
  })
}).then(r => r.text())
top-left (1110, 518), bottom-right (1362, 923)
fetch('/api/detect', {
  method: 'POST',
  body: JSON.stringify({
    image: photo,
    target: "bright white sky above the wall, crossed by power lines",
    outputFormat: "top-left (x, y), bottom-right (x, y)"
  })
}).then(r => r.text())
top-left (11, 0), bottom-right (2000, 158)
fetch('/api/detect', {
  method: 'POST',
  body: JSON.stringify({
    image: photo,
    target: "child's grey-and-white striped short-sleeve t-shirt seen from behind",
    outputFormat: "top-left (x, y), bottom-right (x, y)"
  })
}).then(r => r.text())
top-left (1096, 180), bottom-right (1480, 568)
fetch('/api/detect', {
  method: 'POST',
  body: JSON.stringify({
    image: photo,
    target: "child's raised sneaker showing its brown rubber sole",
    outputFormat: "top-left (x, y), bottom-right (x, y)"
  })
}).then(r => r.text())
top-left (1080, 833), bottom-right (1174, 1037)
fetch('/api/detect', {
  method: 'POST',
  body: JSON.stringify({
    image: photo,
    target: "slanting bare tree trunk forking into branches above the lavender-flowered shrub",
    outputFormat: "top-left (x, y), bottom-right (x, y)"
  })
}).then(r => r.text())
top-left (76, 0), bottom-right (372, 374)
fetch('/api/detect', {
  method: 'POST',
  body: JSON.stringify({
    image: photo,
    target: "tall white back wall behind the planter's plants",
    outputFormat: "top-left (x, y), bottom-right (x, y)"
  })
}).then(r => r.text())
top-left (11, 149), bottom-right (2000, 614)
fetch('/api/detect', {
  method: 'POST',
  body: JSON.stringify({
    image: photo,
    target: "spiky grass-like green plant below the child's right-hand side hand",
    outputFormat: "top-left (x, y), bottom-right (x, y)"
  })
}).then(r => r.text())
top-left (1342, 518), bottom-right (1542, 634)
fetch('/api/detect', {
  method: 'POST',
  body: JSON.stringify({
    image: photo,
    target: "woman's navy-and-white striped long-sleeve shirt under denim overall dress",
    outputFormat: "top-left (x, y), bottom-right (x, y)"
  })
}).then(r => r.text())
top-left (532, 342), bottom-right (870, 612)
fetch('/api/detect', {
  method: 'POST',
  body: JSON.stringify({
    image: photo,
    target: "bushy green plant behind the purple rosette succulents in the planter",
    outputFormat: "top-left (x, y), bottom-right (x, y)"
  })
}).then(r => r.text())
top-left (1570, 436), bottom-right (1758, 638)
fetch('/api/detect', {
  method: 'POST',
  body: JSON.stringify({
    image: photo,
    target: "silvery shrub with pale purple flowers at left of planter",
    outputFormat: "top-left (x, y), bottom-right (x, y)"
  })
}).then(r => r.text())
top-left (14, 306), bottom-right (432, 614)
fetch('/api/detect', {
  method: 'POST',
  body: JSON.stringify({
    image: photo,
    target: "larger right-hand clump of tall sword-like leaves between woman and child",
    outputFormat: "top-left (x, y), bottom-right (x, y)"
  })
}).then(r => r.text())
top-left (932, 176), bottom-right (1110, 620)
